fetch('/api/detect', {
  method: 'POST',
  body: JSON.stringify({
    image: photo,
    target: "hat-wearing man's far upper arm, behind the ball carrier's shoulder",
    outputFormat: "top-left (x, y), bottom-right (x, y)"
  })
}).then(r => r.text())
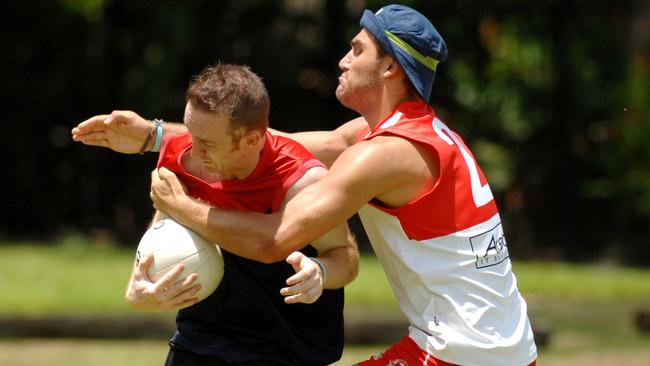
top-left (271, 117), bottom-right (367, 167)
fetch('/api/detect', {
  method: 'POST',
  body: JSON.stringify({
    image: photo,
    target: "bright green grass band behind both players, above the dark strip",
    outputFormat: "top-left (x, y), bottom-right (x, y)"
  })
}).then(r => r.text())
top-left (0, 240), bottom-right (650, 315)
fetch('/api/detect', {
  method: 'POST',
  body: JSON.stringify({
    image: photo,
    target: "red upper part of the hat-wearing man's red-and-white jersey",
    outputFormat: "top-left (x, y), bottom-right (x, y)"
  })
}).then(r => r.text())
top-left (359, 101), bottom-right (497, 240)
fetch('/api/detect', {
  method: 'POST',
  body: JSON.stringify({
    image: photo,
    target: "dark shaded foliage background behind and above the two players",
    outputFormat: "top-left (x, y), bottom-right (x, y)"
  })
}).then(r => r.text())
top-left (0, 0), bottom-right (650, 265)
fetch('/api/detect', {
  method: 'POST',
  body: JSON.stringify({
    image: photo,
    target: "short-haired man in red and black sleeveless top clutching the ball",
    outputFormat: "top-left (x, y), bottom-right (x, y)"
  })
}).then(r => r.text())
top-left (82, 64), bottom-right (358, 366)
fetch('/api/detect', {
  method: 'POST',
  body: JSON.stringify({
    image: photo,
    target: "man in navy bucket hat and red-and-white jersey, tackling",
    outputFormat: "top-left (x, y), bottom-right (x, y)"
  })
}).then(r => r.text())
top-left (72, 5), bottom-right (537, 366)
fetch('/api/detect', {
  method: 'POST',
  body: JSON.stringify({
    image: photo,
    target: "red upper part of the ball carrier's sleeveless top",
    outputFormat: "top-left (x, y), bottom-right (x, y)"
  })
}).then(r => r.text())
top-left (158, 132), bottom-right (324, 213)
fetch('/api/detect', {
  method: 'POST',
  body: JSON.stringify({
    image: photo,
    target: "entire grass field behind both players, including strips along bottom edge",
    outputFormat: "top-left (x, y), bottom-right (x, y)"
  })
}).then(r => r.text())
top-left (0, 242), bottom-right (650, 366)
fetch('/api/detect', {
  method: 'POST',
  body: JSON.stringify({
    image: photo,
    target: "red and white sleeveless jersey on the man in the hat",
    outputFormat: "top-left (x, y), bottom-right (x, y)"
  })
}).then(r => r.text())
top-left (359, 102), bottom-right (537, 366)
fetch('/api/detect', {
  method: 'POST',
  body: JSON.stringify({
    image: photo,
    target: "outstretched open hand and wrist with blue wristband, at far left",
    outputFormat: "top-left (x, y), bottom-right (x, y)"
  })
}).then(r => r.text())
top-left (71, 111), bottom-right (187, 154)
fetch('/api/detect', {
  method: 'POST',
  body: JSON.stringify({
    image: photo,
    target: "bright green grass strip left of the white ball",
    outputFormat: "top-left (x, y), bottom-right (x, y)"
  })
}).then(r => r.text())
top-left (0, 243), bottom-right (133, 316)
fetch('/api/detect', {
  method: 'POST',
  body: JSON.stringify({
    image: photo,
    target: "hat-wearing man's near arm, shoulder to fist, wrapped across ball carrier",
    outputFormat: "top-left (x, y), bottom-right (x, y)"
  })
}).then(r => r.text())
top-left (152, 137), bottom-right (428, 268)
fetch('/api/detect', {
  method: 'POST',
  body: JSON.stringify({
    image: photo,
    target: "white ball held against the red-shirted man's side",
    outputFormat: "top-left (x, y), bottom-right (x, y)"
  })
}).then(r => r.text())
top-left (136, 217), bottom-right (223, 301)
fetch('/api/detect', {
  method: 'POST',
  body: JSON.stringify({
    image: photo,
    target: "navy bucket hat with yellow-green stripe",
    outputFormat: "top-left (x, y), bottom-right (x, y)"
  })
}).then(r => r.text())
top-left (359, 5), bottom-right (447, 102)
